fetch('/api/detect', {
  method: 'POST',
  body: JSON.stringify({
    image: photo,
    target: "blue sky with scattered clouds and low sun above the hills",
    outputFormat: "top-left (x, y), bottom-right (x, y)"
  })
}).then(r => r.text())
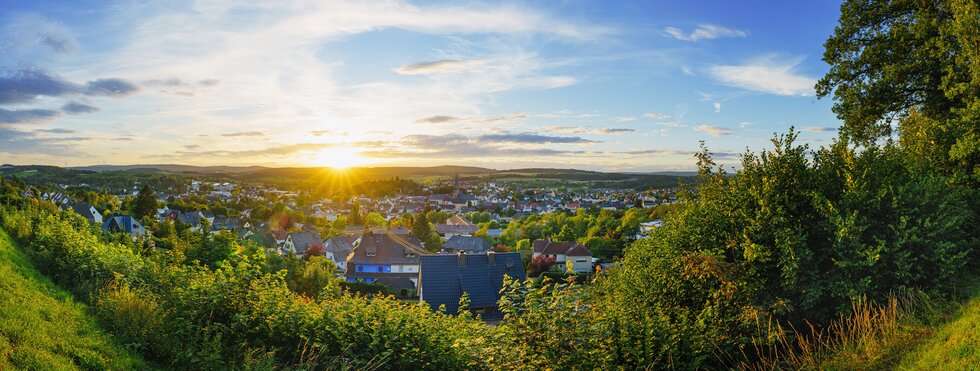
top-left (0, 0), bottom-right (840, 172)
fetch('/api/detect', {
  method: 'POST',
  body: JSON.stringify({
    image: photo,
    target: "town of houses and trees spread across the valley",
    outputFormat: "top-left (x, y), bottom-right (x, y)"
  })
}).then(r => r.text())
top-left (7, 165), bottom-right (678, 322)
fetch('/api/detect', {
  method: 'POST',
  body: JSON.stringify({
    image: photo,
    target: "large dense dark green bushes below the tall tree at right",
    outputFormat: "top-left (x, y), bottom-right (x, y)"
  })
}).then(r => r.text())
top-left (595, 131), bottom-right (977, 367)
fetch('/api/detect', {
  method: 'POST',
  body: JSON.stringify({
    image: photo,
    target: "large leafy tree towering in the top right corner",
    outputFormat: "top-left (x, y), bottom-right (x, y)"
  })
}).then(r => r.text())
top-left (817, 0), bottom-right (980, 187)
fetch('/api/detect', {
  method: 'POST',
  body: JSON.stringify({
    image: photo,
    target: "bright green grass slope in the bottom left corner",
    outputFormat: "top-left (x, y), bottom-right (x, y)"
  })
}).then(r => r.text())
top-left (0, 230), bottom-right (150, 370)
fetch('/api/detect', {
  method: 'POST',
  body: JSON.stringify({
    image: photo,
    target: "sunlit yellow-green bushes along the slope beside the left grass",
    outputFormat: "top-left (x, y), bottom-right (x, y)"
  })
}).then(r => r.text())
top-left (0, 204), bottom-right (487, 369)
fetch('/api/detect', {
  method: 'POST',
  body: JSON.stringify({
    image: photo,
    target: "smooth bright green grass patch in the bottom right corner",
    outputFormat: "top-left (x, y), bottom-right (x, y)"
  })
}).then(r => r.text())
top-left (899, 288), bottom-right (980, 370)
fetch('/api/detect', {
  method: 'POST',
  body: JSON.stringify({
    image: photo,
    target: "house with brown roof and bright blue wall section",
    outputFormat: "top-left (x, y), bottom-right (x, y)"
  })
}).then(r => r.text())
top-left (344, 231), bottom-right (429, 291)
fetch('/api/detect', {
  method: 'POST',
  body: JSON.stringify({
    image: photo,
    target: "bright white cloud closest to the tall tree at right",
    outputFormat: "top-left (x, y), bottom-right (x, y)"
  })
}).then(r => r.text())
top-left (709, 55), bottom-right (817, 96)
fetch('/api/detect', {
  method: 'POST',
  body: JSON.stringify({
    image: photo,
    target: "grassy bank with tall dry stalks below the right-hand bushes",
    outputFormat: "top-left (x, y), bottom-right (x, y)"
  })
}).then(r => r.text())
top-left (738, 284), bottom-right (980, 370)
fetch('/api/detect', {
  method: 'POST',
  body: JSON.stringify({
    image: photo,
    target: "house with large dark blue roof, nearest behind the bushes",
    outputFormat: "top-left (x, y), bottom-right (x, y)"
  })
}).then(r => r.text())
top-left (418, 252), bottom-right (527, 320)
